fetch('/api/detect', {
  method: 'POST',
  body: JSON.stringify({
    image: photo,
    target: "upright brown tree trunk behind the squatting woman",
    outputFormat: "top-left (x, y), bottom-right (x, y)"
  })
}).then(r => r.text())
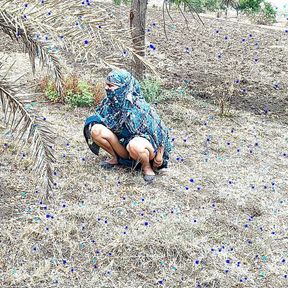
top-left (130, 0), bottom-right (148, 80)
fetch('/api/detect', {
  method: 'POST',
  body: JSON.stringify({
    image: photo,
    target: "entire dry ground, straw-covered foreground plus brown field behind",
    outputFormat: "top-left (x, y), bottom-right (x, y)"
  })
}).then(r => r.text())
top-left (0, 0), bottom-right (288, 288)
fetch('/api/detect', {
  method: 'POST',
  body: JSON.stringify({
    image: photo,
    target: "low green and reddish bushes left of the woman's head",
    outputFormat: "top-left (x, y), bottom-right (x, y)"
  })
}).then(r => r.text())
top-left (39, 75), bottom-right (106, 107)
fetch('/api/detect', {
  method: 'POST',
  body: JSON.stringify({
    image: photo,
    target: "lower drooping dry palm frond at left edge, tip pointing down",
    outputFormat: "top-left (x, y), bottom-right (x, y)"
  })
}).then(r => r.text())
top-left (0, 68), bottom-right (55, 197)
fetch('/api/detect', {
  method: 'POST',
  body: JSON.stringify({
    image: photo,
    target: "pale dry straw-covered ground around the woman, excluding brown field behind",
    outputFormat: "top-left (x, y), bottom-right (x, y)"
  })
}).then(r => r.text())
top-left (0, 1), bottom-right (288, 288)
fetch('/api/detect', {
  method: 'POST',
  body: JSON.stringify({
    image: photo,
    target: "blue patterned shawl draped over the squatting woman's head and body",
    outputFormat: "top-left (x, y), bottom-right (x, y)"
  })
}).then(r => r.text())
top-left (84, 69), bottom-right (173, 168)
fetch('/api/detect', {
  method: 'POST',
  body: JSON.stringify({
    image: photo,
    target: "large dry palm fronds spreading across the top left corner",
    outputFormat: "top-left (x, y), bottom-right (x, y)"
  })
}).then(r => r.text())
top-left (0, 0), bottom-right (155, 81)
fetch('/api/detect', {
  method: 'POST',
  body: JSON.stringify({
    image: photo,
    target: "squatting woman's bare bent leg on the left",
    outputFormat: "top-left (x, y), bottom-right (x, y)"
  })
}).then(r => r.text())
top-left (91, 124), bottom-right (129, 164)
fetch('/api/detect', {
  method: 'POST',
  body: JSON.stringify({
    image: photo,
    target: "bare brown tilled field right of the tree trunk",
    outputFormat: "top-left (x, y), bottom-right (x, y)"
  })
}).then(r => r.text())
top-left (143, 11), bottom-right (288, 123)
